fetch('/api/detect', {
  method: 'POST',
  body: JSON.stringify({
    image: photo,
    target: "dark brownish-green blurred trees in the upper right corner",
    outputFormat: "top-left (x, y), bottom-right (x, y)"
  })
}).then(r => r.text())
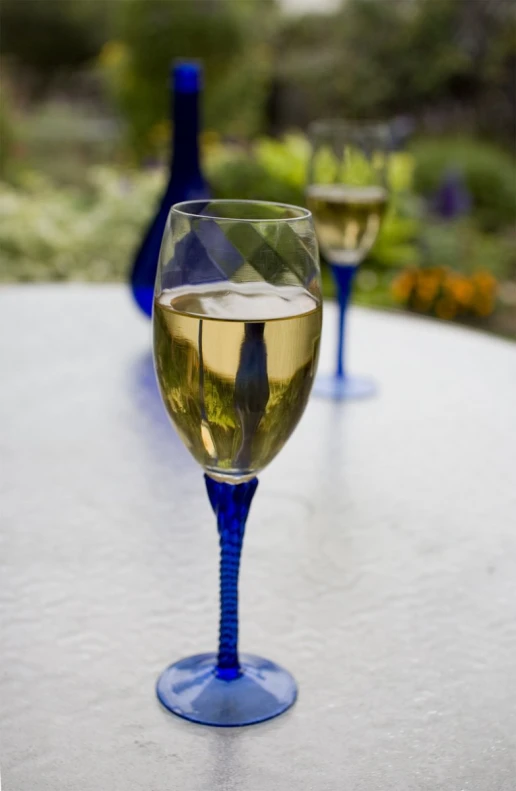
top-left (276, 0), bottom-right (516, 145)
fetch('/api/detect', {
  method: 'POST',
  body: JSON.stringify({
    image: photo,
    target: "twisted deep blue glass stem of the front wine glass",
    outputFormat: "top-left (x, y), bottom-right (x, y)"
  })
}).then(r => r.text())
top-left (204, 475), bottom-right (258, 680)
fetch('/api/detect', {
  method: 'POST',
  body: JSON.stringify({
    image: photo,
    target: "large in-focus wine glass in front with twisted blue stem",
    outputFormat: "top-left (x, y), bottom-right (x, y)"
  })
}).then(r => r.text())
top-left (153, 200), bottom-right (322, 726)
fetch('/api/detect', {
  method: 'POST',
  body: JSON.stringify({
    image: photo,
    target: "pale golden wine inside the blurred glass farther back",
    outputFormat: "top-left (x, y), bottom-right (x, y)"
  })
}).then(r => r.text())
top-left (306, 184), bottom-right (387, 266)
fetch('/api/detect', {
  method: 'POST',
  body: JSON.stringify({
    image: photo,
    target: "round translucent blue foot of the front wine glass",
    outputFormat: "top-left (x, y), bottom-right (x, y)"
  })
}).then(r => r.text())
top-left (156, 654), bottom-right (297, 728)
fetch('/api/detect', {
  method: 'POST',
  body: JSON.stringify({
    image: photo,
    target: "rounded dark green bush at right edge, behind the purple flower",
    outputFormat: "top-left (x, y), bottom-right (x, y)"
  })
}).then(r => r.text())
top-left (412, 138), bottom-right (516, 230)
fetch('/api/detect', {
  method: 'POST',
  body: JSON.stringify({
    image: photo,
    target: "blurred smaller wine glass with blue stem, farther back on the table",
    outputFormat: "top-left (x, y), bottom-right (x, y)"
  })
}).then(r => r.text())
top-left (306, 120), bottom-right (391, 400)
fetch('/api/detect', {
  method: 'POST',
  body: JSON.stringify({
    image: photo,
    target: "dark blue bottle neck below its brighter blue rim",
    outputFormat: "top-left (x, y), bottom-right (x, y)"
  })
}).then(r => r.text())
top-left (171, 91), bottom-right (200, 180)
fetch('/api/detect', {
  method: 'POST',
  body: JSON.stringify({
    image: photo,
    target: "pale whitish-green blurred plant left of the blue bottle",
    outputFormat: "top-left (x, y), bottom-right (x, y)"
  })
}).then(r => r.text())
top-left (0, 168), bottom-right (163, 282)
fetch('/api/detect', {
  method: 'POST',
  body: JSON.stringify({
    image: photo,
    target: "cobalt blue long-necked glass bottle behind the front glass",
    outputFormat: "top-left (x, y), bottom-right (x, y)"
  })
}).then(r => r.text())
top-left (131, 61), bottom-right (209, 316)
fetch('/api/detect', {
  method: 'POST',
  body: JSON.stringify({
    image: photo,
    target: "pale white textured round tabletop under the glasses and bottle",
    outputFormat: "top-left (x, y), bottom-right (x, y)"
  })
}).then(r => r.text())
top-left (0, 285), bottom-right (516, 791)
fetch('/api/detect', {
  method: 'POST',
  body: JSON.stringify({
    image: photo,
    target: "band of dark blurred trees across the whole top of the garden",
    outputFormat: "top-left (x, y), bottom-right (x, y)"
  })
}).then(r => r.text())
top-left (0, 0), bottom-right (516, 159)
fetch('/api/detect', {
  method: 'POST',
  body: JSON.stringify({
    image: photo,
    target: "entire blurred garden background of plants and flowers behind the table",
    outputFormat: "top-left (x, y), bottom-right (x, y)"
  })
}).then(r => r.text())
top-left (0, 0), bottom-right (516, 338)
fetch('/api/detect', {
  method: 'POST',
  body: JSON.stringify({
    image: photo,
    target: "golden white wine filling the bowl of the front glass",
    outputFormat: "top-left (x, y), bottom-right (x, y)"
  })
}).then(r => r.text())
top-left (154, 282), bottom-right (322, 483)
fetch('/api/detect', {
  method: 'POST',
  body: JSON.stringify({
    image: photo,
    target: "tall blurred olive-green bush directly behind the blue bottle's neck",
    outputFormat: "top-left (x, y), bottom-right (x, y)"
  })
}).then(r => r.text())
top-left (99, 0), bottom-right (274, 159)
